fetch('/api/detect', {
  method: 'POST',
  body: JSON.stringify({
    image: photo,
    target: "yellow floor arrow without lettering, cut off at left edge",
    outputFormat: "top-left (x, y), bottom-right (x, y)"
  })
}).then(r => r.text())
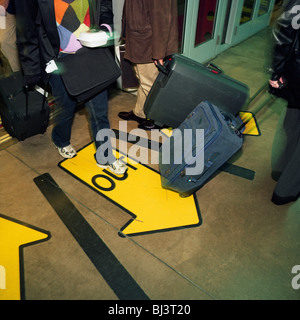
top-left (0, 214), bottom-right (50, 300)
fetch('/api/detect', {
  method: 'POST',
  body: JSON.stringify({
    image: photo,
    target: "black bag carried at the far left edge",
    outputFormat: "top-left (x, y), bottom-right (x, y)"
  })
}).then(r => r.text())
top-left (0, 72), bottom-right (50, 141)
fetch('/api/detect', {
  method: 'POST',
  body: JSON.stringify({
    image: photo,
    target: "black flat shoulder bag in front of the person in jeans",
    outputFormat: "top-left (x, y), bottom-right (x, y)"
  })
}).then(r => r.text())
top-left (57, 47), bottom-right (121, 102)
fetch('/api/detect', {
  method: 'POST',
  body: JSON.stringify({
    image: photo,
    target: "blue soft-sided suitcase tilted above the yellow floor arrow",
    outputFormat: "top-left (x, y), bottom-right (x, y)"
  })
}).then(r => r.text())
top-left (159, 101), bottom-right (243, 197)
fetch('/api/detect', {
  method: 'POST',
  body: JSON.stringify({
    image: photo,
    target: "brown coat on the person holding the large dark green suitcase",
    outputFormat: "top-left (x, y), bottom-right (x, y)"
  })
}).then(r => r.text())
top-left (122, 0), bottom-right (178, 63)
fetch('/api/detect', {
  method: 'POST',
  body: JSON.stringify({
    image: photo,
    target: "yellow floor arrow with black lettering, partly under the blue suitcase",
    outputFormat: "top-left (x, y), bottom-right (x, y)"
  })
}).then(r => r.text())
top-left (59, 144), bottom-right (201, 235)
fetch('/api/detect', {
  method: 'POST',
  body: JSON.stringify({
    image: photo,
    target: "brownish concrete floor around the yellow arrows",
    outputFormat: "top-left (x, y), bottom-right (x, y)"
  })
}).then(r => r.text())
top-left (0, 29), bottom-right (300, 301)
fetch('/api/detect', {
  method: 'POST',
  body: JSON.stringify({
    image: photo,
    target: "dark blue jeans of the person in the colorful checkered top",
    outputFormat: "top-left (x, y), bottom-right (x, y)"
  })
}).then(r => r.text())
top-left (49, 73), bottom-right (115, 164)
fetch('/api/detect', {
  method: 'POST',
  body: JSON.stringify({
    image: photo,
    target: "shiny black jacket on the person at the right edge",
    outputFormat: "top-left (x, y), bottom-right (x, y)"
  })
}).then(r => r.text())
top-left (272, 0), bottom-right (300, 108)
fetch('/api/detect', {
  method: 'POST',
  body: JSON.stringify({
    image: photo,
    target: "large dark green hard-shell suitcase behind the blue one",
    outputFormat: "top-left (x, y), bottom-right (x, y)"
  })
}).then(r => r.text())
top-left (144, 54), bottom-right (249, 128)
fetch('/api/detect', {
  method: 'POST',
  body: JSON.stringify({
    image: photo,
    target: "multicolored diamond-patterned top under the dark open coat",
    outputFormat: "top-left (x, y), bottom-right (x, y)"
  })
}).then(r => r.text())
top-left (54, 0), bottom-right (90, 52)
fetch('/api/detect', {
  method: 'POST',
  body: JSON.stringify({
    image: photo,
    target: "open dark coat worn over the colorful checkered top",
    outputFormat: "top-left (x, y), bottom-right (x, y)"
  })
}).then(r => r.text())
top-left (15, 0), bottom-right (113, 82)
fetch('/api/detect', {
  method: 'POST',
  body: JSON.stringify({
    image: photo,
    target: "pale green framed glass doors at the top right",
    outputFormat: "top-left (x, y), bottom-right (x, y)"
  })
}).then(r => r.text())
top-left (180, 0), bottom-right (275, 63)
